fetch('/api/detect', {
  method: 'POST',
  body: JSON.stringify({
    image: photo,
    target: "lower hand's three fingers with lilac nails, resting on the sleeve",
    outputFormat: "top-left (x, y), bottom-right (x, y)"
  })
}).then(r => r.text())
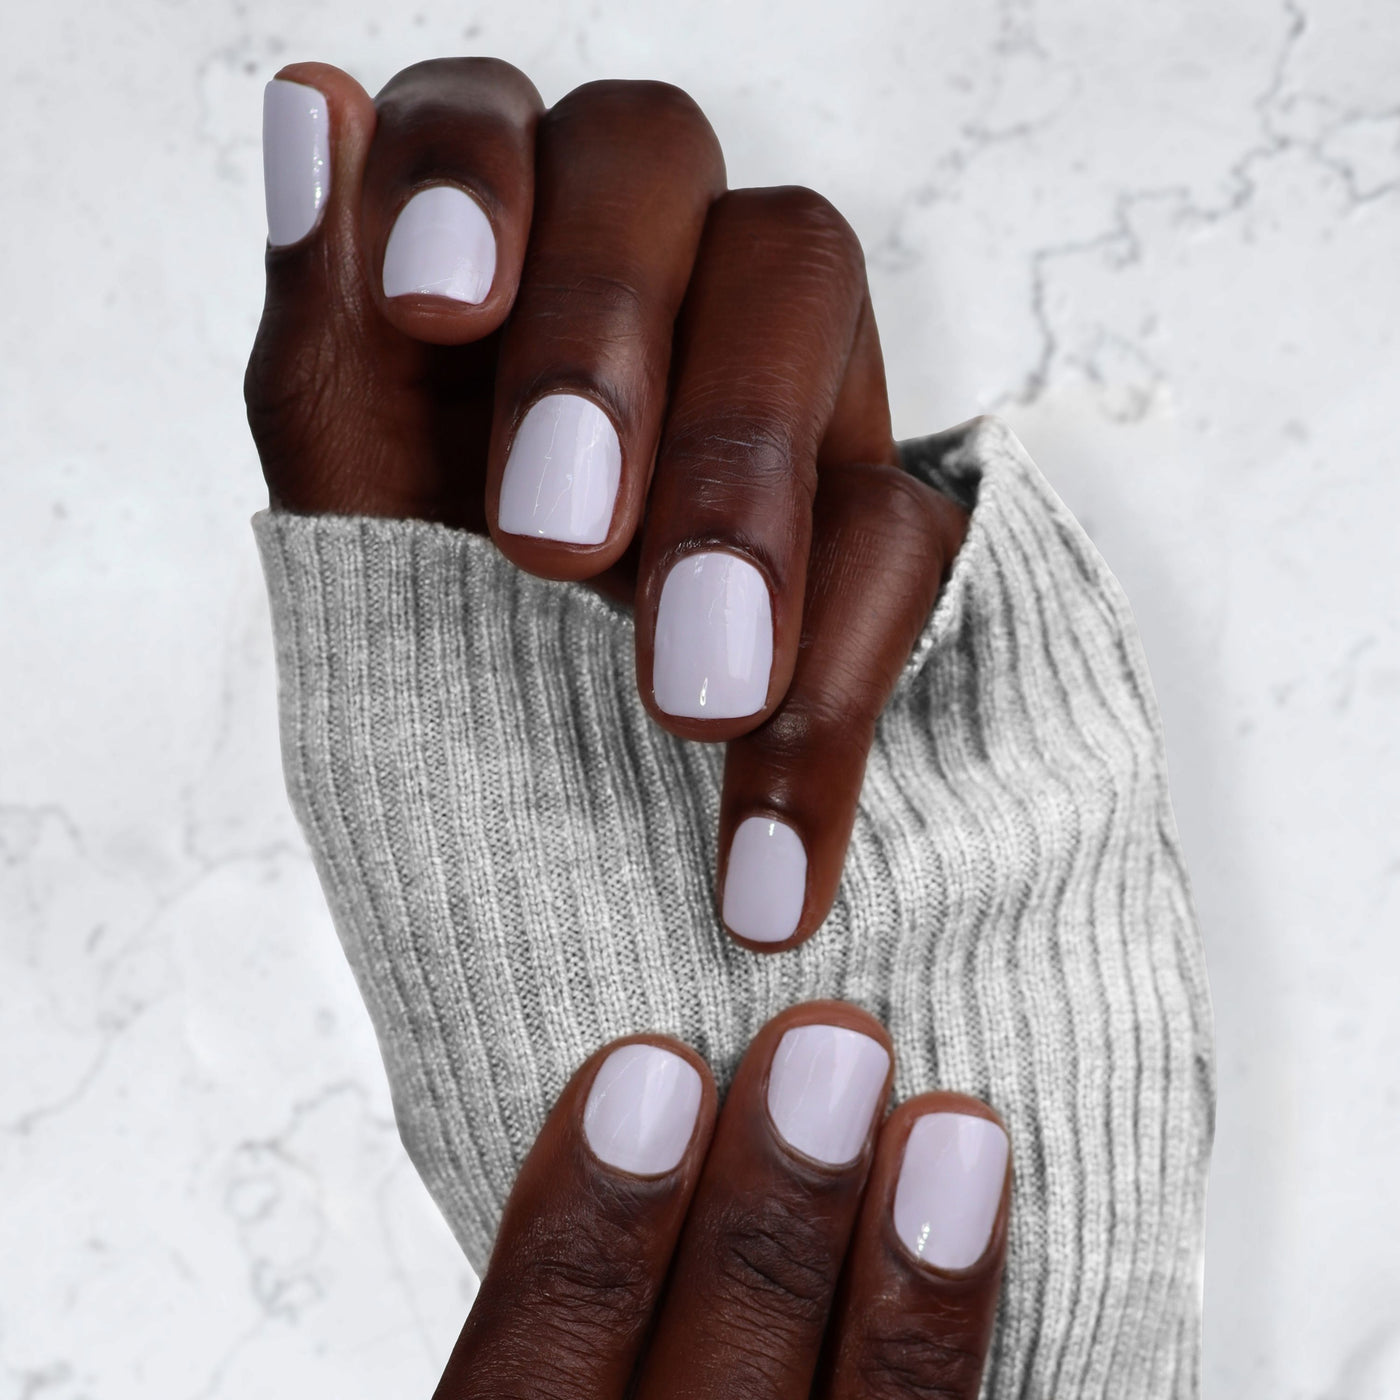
top-left (437, 1002), bottom-right (1011, 1400)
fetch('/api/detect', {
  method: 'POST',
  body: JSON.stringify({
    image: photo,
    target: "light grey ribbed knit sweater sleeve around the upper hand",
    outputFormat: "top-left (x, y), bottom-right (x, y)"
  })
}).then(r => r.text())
top-left (255, 419), bottom-right (1214, 1400)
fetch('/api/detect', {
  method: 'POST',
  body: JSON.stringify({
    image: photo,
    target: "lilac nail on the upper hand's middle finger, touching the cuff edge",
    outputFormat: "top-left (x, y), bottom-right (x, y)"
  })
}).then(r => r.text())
top-left (497, 393), bottom-right (622, 545)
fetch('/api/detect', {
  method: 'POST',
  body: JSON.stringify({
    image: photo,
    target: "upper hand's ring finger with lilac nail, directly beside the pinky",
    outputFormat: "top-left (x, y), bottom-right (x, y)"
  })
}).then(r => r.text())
top-left (637, 189), bottom-right (892, 739)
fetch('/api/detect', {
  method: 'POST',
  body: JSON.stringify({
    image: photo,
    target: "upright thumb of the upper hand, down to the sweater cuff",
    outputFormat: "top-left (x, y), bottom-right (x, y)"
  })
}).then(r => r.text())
top-left (244, 63), bottom-right (496, 529)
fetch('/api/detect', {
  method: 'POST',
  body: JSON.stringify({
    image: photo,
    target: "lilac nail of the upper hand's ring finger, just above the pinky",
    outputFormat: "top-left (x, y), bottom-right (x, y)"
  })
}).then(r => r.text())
top-left (651, 550), bottom-right (773, 720)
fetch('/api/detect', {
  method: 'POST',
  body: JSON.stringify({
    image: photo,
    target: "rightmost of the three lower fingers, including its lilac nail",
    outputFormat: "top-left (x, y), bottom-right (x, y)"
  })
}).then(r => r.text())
top-left (819, 1093), bottom-right (1011, 1400)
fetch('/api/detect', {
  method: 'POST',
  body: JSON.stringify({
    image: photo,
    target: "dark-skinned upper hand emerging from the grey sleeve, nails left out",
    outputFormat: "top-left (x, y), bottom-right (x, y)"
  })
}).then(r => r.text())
top-left (246, 59), bottom-right (967, 952)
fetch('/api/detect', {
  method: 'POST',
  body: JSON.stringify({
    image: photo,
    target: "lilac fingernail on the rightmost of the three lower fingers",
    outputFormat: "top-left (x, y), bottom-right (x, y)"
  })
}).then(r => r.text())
top-left (895, 1113), bottom-right (1008, 1268)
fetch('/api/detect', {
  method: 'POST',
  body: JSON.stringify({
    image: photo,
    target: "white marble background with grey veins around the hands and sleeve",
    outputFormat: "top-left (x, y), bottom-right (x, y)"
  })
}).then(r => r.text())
top-left (0, 0), bottom-right (1400, 1400)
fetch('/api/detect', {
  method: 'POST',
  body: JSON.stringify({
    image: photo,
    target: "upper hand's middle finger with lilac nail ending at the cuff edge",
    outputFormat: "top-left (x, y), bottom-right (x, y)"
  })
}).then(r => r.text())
top-left (487, 83), bottom-right (724, 578)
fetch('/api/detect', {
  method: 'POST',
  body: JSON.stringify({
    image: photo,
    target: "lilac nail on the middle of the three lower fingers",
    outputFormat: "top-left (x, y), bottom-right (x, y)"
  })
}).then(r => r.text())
top-left (769, 1026), bottom-right (889, 1166)
